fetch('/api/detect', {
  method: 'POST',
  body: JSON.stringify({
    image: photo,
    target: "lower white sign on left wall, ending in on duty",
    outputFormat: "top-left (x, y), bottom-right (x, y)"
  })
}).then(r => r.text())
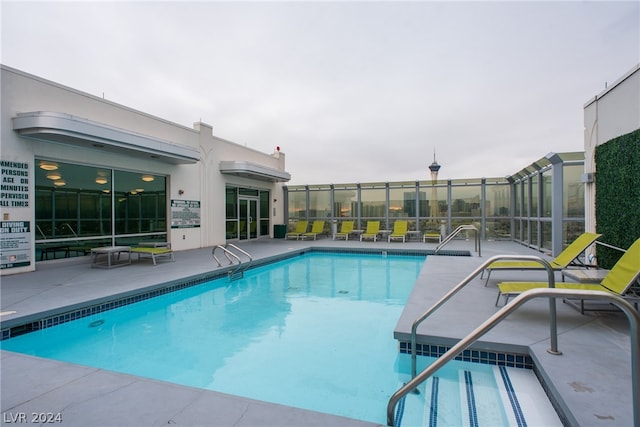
top-left (0, 221), bottom-right (31, 269)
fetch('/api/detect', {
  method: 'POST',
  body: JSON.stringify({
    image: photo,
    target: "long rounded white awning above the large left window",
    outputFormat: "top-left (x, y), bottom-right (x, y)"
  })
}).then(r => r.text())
top-left (12, 111), bottom-right (200, 164)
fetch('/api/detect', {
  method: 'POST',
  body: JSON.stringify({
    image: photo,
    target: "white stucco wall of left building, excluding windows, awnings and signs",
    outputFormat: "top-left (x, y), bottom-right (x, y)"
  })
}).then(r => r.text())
top-left (0, 66), bottom-right (284, 274)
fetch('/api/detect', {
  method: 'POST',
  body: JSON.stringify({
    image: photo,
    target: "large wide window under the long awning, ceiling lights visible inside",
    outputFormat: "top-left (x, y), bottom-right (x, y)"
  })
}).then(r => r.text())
top-left (35, 160), bottom-right (167, 260)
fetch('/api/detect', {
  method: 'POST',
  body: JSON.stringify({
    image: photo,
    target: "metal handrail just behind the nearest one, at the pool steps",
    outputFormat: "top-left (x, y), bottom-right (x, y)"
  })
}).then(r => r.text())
top-left (411, 255), bottom-right (558, 378)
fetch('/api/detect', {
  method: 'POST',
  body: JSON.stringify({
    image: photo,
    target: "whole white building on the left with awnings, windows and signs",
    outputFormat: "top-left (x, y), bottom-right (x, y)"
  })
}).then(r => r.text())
top-left (0, 66), bottom-right (290, 274)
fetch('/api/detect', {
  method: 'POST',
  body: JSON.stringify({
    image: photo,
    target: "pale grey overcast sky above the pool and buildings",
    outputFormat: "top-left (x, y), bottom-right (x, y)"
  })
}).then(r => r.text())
top-left (0, 0), bottom-right (640, 185)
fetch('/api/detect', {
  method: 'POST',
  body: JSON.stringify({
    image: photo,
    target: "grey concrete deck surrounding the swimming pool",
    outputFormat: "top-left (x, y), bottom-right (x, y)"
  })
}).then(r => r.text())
top-left (0, 239), bottom-right (634, 426)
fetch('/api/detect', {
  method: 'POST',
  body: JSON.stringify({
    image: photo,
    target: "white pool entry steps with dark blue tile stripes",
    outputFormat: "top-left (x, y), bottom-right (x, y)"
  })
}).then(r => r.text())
top-left (396, 366), bottom-right (562, 427)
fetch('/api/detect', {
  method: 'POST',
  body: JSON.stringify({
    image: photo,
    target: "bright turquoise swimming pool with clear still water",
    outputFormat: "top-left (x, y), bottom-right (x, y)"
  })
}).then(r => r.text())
top-left (2, 253), bottom-right (560, 425)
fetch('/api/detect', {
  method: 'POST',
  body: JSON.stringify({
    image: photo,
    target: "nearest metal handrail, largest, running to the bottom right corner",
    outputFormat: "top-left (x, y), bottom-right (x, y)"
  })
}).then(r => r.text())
top-left (387, 288), bottom-right (640, 426)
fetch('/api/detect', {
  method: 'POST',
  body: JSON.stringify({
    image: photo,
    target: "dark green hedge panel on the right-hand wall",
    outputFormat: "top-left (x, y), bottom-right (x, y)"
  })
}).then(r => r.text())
top-left (595, 129), bottom-right (640, 268)
